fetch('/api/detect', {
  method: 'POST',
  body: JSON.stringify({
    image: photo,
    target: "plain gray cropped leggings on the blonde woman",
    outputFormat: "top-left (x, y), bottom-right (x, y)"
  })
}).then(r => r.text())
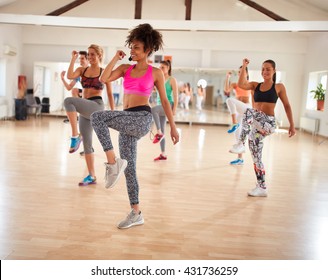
top-left (64, 97), bottom-right (105, 154)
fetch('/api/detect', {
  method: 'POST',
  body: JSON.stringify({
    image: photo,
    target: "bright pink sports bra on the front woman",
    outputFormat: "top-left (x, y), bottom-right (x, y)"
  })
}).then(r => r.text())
top-left (123, 64), bottom-right (154, 96)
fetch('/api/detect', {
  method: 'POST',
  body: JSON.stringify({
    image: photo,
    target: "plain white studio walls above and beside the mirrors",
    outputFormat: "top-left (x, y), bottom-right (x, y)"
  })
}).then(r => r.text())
top-left (0, 25), bottom-right (328, 135)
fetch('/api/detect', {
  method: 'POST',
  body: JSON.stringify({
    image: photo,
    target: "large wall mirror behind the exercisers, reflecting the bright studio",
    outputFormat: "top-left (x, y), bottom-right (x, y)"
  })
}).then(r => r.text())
top-left (33, 62), bottom-right (279, 125)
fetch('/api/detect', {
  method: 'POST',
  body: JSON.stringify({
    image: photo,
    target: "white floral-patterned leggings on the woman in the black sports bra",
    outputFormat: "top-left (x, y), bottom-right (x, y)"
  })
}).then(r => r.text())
top-left (239, 108), bottom-right (276, 189)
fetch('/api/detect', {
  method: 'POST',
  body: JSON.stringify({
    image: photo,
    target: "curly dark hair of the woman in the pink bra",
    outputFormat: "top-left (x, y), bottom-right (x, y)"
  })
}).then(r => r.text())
top-left (125, 23), bottom-right (163, 56)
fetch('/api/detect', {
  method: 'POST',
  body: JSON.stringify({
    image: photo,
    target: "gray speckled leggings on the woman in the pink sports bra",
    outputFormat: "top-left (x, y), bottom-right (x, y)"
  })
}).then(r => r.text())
top-left (91, 107), bottom-right (152, 205)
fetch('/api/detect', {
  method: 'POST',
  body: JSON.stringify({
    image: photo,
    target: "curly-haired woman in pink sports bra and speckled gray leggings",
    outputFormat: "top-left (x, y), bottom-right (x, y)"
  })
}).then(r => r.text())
top-left (91, 24), bottom-right (179, 229)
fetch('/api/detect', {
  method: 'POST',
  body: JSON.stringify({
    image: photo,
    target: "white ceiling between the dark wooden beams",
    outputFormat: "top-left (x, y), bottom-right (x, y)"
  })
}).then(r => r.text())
top-left (0, 0), bottom-right (328, 21)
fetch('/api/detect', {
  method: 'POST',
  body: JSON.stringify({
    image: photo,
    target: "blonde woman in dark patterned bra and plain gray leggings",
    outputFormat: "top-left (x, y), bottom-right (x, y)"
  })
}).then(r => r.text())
top-left (64, 44), bottom-right (114, 186)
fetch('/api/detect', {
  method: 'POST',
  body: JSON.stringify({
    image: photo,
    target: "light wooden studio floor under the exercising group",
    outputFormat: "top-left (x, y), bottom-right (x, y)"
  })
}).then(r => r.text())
top-left (0, 112), bottom-right (328, 260)
